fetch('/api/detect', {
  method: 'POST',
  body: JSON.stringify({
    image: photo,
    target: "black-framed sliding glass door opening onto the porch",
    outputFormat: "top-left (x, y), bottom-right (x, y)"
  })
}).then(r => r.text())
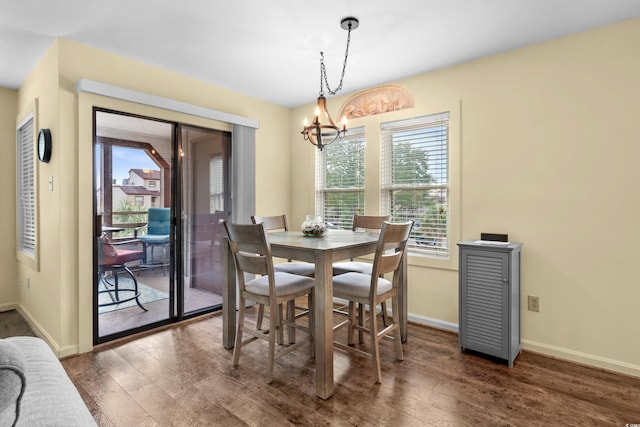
top-left (94, 109), bottom-right (231, 343)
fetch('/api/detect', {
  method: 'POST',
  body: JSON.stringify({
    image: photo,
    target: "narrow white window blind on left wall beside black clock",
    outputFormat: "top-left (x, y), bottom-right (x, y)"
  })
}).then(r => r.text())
top-left (16, 115), bottom-right (36, 258)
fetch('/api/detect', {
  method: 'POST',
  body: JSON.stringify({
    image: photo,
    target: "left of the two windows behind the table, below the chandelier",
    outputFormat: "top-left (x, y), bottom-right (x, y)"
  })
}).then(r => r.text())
top-left (316, 127), bottom-right (365, 229)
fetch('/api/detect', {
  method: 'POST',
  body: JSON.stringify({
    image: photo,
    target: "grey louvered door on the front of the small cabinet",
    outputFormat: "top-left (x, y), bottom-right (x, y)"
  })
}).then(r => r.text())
top-left (460, 250), bottom-right (509, 359)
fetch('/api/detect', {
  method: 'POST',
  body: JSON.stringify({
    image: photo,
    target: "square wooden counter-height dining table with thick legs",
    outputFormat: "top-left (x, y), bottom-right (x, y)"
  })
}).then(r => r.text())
top-left (222, 230), bottom-right (407, 399)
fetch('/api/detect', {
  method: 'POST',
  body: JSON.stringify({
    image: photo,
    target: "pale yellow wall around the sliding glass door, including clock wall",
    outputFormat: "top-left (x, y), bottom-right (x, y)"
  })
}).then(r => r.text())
top-left (9, 39), bottom-right (290, 355)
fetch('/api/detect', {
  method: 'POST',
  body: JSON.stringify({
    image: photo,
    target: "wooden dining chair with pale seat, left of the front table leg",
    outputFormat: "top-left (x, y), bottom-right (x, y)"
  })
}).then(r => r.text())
top-left (224, 221), bottom-right (315, 383)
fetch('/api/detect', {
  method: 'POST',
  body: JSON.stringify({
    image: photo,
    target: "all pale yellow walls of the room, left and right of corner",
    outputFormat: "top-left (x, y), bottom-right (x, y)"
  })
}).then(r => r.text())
top-left (0, 16), bottom-right (640, 375)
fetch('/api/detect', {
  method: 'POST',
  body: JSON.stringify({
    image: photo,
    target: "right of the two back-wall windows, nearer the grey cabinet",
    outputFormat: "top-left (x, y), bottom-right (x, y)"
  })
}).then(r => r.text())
top-left (381, 112), bottom-right (450, 259)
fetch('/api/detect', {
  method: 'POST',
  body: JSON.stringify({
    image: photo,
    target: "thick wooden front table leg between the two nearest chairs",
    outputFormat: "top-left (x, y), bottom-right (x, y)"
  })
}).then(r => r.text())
top-left (313, 251), bottom-right (333, 399)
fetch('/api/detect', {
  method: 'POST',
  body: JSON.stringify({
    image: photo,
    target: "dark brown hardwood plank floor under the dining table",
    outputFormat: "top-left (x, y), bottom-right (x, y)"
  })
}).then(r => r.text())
top-left (63, 308), bottom-right (640, 426)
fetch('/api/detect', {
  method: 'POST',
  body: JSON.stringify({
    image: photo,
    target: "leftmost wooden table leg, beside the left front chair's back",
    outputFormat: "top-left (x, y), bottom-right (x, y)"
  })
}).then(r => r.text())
top-left (221, 237), bottom-right (236, 348)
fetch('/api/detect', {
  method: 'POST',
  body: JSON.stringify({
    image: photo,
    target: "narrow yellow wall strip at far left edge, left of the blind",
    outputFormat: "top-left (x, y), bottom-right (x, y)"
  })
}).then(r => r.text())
top-left (0, 88), bottom-right (18, 311)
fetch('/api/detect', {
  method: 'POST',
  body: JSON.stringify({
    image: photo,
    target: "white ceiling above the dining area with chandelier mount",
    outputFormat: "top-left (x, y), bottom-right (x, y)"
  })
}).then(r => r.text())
top-left (0, 0), bottom-right (640, 107)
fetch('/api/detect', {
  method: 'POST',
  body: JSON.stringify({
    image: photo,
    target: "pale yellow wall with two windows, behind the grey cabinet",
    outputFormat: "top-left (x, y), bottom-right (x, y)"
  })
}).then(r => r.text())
top-left (291, 20), bottom-right (640, 375)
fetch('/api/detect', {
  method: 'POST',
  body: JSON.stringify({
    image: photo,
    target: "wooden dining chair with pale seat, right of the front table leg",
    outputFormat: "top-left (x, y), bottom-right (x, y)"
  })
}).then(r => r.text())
top-left (333, 221), bottom-right (413, 383)
